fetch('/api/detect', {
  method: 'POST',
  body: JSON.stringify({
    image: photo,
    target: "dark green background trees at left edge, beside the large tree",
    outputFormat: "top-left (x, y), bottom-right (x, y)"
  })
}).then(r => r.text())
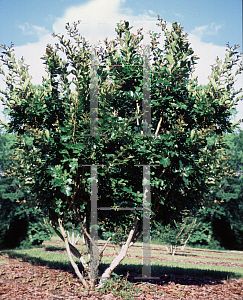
top-left (0, 132), bottom-right (49, 249)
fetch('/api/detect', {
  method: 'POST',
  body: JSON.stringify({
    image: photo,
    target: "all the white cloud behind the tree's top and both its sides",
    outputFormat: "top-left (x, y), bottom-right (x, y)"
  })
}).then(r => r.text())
top-left (0, 0), bottom-right (243, 127)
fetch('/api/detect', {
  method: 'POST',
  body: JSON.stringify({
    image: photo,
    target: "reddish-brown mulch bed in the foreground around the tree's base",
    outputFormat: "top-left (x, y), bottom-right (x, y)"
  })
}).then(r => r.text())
top-left (0, 255), bottom-right (243, 300)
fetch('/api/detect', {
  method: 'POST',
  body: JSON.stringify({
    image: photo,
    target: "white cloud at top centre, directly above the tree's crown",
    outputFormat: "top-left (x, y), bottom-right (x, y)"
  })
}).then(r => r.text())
top-left (53, 0), bottom-right (157, 44)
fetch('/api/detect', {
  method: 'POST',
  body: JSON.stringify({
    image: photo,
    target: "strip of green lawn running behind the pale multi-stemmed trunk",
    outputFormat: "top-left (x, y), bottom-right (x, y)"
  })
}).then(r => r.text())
top-left (0, 236), bottom-right (243, 279)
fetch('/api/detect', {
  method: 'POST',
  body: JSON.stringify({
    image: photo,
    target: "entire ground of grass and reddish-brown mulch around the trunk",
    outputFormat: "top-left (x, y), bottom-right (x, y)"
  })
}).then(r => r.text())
top-left (0, 236), bottom-right (243, 300)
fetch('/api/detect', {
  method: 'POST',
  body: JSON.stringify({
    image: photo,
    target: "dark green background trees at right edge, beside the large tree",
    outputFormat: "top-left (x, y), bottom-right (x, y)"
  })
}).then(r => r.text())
top-left (185, 131), bottom-right (243, 250)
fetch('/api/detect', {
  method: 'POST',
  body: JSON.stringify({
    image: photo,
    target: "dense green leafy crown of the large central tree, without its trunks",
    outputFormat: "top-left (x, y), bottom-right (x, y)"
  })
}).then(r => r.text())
top-left (0, 20), bottom-right (241, 229)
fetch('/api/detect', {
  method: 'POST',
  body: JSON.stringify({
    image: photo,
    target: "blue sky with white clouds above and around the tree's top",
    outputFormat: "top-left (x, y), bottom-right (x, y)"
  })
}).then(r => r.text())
top-left (0, 0), bottom-right (243, 129)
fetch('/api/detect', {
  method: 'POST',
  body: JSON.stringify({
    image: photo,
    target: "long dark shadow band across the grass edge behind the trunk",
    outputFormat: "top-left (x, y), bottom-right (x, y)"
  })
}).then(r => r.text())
top-left (2, 247), bottom-right (242, 286)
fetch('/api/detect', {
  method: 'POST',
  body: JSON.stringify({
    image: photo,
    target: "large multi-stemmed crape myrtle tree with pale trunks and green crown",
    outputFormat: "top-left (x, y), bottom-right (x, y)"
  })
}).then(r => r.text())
top-left (2, 16), bottom-right (242, 289)
